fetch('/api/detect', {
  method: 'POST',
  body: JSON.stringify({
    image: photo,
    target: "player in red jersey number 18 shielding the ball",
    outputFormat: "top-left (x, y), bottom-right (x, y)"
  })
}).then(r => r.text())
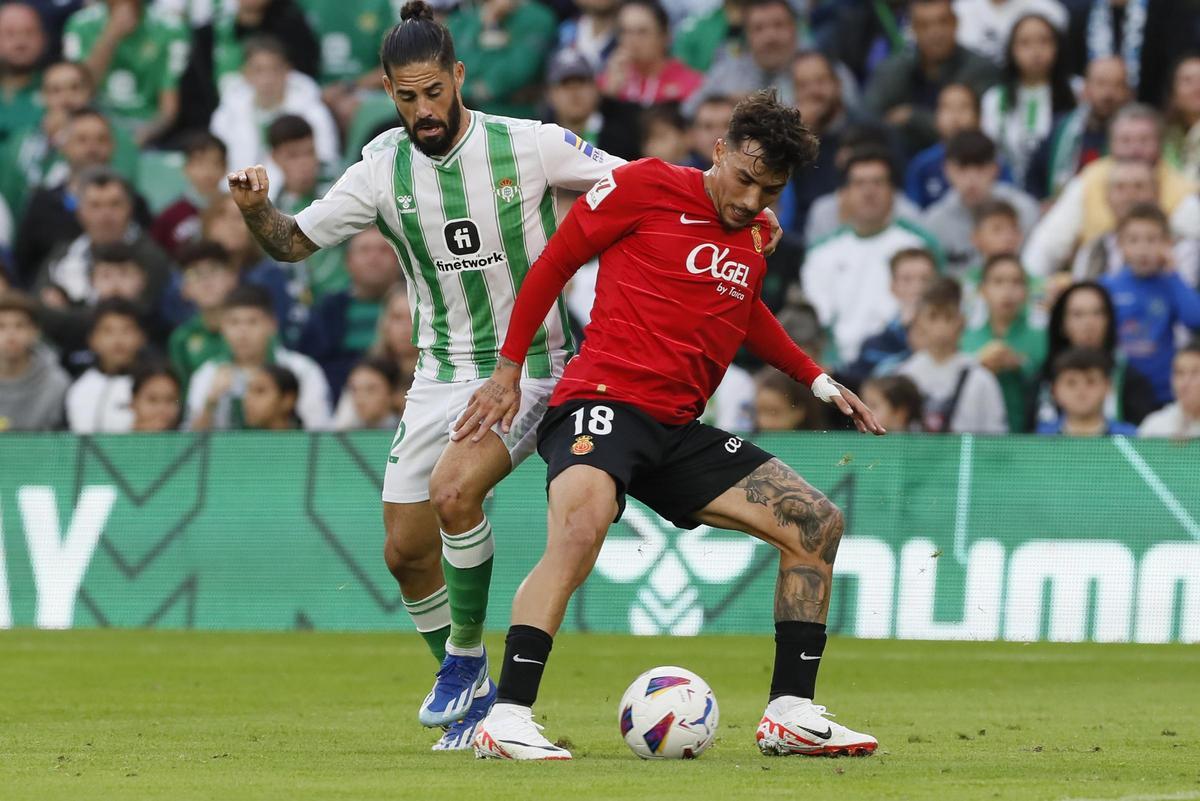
top-left (455, 92), bottom-right (883, 759)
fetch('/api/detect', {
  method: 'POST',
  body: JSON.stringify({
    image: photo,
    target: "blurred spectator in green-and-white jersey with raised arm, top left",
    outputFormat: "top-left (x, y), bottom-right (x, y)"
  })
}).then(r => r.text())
top-left (62, 0), bottom-right (191, 145)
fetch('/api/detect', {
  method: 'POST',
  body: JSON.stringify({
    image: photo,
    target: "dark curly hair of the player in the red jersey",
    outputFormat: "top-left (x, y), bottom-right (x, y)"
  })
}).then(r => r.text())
top-left (725, 89), bottom-right (821, 178)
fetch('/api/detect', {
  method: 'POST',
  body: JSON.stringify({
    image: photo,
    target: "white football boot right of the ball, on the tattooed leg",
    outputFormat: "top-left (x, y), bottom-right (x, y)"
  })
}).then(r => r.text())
top-left (755, 695), bottom-right (880, 757)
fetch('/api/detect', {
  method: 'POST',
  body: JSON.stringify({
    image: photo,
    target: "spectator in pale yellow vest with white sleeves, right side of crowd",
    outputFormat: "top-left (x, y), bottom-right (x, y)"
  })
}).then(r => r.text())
top-left (1024, 104), bottom-right (1200, 276)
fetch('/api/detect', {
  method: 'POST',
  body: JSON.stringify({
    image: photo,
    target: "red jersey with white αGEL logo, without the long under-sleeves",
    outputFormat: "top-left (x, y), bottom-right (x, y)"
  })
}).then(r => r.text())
top-left (551, 159), bottom-right (770, 424)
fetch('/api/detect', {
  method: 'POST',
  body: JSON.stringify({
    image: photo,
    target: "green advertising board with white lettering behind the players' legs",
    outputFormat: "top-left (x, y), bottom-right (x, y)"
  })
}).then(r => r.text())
top-left (0, 433), bottom-right (1200, 643)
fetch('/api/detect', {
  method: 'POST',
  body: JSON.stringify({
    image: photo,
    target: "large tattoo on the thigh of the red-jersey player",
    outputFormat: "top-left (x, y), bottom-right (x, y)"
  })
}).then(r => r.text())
top-left (734, 459), bottom-right (844, 565)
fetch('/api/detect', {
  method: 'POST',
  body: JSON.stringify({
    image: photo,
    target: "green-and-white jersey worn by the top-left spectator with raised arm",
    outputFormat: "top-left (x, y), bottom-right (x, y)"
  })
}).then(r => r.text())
top-left (62, 2), bottom-right (191, 122)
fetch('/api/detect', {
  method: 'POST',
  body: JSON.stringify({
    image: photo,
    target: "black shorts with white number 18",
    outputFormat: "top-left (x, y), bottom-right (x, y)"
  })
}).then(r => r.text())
top-left (538, 401), bottom-right (772, 529)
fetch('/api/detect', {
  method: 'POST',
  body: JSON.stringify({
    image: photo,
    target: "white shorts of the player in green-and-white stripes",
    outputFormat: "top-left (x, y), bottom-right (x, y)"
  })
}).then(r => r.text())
top-left (383, 375), bottom-right (558, 504)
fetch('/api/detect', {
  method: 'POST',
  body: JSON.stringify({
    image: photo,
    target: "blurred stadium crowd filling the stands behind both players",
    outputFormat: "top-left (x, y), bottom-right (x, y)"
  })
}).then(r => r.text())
top-left (0, 0), bottom-right (1200, 438)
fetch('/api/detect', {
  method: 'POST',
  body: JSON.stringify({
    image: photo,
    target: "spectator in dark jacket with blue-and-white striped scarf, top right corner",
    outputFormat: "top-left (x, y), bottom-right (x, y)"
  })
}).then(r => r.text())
top-left (1068, 0), bottom-right (1196, 106)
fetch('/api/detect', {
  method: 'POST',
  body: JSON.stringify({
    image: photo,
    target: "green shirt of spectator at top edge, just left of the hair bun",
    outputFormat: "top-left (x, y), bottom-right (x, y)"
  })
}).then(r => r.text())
top-left (300, 0), bottom-right (398, 84)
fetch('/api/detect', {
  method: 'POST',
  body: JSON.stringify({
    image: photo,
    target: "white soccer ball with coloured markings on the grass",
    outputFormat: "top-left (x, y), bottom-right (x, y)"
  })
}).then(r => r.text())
top-left (617, 666), bottom-right (720, 759)
